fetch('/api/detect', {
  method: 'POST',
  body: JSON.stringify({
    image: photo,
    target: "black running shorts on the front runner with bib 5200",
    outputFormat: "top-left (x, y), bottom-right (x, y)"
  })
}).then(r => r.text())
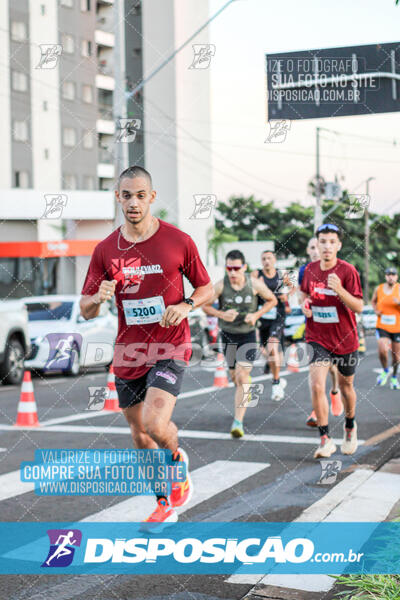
top-left (115, 358), bottom-right (185, 408)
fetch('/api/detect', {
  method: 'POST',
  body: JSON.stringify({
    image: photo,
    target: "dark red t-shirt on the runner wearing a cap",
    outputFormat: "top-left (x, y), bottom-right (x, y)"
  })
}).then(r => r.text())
top-left (300, 258), bottom-right (363, 354)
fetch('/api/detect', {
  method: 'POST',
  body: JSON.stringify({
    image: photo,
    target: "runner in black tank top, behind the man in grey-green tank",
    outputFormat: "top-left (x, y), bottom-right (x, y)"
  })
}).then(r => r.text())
top-left (251, 250), bottom-right (287, 402)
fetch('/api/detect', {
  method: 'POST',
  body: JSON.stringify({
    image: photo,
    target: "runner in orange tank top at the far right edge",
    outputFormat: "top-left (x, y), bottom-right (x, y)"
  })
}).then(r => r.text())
top-left (371, 267), bottom-right (400, 390)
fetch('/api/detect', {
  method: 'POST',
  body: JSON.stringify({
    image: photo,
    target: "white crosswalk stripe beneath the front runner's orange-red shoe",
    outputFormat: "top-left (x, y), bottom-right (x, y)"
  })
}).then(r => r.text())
top-left (82, 460), bottom-right (270, 523)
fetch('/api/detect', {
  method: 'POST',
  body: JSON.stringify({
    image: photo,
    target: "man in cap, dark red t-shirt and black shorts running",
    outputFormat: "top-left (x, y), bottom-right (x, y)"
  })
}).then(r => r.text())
top-left (300, 223), bottom-right (363, 458)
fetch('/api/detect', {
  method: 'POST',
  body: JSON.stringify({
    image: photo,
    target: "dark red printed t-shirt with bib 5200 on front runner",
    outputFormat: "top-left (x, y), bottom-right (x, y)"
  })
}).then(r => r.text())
top-left (82, 219), bottom-right (210, 379)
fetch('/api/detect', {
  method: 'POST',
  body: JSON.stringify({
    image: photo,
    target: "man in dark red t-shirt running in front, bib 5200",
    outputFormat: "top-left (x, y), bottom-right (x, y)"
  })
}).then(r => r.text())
top-left (80, 166), bottom-right (213, 530)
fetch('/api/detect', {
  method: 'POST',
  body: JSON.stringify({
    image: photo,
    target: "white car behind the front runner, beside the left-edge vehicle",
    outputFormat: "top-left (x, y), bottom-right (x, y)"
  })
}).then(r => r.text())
top-left (24, 295), bottom-right (118, 375)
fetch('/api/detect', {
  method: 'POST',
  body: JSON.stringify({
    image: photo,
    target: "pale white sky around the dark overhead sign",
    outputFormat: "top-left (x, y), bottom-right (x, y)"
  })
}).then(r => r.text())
top-left (209, 0), bottom-right (400, 213)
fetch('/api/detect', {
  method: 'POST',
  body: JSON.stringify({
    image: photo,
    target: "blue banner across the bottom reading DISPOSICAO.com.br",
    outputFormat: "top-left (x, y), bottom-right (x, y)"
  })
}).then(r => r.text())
top-left (0, 522), bottom-right (400, 575)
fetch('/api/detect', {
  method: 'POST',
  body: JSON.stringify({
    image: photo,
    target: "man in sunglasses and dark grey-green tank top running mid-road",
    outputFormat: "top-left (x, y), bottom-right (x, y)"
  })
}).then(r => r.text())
top-left (202, 250), bottom-right (277, 438)
